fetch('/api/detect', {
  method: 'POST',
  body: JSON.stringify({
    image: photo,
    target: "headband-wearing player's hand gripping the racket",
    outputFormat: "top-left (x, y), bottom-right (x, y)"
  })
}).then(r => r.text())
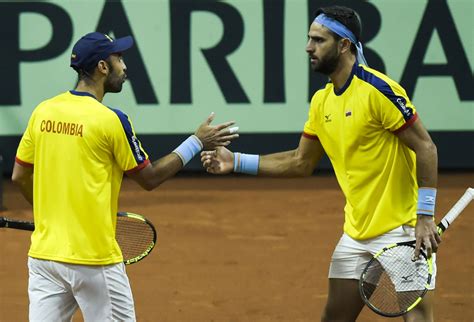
top-left (414, 215), bottom-right (441, 259)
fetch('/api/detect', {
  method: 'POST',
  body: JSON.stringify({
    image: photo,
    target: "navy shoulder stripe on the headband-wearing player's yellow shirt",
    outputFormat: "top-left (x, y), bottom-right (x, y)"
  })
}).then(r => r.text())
top-left (355, 66), bottom-right (413, 121)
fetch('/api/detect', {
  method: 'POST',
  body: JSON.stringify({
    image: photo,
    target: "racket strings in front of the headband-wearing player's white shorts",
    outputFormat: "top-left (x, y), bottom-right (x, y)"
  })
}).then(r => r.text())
top-left (361, 245), bottom-right (429, 314)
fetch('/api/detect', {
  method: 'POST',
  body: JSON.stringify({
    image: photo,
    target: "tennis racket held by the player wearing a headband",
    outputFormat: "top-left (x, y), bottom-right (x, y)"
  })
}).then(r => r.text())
top-left (359, 188), bottom-right (474, 317)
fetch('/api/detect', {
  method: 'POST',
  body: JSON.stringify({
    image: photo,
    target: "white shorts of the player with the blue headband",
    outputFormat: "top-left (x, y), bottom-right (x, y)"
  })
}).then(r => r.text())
top-left (329, 225), bottom-right (436, 290)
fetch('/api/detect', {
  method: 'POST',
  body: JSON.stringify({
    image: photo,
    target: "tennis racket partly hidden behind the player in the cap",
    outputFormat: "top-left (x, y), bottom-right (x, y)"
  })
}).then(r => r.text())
top-left (0, 212), bottom-right (156, 265)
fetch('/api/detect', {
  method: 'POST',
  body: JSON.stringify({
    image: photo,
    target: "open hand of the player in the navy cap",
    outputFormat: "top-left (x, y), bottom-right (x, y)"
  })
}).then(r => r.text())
top-left (194, 113), bottom-right (239, 150)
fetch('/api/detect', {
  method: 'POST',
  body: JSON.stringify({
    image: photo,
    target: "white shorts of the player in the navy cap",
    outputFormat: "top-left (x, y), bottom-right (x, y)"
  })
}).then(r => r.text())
top-left (28, 257), bottom-right (136, 322)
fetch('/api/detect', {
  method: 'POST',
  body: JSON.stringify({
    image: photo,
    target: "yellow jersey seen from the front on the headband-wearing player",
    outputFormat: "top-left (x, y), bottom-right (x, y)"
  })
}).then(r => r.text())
top-left (303, 64), bottom-right (418, 239)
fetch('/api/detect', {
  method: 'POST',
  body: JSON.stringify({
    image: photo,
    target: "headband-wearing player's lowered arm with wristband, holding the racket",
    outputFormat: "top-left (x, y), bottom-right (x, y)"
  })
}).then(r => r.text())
top-left (397, 119), bottom-right (441, 256)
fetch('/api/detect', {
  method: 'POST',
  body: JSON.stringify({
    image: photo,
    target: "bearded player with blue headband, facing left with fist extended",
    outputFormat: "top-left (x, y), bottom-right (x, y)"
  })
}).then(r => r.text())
top-left (201, 6), bottom-right (441, 321)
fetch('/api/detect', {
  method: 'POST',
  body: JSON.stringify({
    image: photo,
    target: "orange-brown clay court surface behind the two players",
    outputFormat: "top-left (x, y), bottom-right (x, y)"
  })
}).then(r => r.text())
top-left (0, 172), bottom-right (474, 322)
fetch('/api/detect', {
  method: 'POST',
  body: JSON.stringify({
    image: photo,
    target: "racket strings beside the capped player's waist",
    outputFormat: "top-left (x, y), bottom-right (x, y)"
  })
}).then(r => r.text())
top-left (115, 216), bottom-right (155, 260)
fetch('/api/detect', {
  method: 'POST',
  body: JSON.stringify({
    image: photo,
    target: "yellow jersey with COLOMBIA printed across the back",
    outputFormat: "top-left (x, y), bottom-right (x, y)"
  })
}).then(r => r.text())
top-left (16, 91), bottom-right (149, 265)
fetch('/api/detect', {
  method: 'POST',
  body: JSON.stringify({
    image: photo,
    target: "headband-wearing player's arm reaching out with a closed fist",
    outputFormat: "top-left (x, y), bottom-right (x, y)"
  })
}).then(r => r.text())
top-left (201, 136), bottom-right (324, 177)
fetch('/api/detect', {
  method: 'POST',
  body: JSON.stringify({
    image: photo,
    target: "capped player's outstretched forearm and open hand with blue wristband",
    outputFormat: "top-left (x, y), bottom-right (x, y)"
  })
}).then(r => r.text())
top-left (127, 113), bottom-right (239, 191)
